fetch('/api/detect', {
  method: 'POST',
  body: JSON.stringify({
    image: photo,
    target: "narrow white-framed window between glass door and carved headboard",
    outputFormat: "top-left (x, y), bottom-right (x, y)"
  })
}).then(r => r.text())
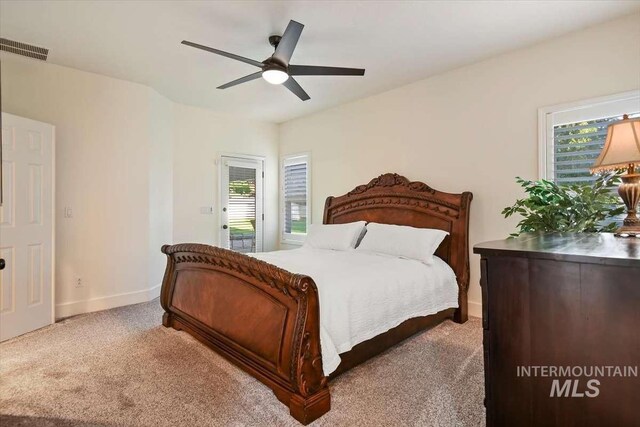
top-left (280, 154), bottom-right (311, 244)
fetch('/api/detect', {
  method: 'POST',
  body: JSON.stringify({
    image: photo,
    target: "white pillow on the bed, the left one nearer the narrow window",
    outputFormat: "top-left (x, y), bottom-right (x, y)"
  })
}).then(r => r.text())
top-left (304, 221), bottom-right (366, 251)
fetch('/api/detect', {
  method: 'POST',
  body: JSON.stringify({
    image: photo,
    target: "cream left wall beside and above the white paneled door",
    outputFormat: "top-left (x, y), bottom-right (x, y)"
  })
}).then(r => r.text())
top-left (2, 55), bottom-right (171, 317)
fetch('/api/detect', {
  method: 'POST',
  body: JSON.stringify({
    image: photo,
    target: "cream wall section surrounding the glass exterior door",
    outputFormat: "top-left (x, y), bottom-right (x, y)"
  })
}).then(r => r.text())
top-left (173, 105), bottom-right (278, 251)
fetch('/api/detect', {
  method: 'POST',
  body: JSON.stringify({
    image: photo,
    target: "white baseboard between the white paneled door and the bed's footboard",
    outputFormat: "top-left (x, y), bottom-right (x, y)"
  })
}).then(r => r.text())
top-left (55, 284), bottom-right (162, 319)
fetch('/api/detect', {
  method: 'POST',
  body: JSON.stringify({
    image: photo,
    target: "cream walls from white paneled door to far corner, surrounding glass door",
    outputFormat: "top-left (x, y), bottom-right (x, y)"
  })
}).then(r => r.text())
top-left (2, 54), bottom-right (278, 317)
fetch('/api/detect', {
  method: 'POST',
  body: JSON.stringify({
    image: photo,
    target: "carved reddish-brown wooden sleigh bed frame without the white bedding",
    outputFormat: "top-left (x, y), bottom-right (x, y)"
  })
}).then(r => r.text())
top-left (160, 174), bottom-right (473, 425)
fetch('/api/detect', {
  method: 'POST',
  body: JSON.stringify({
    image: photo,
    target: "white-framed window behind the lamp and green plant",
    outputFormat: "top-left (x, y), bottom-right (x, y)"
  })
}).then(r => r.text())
top-left (539, 91), bottom-right (640, 184)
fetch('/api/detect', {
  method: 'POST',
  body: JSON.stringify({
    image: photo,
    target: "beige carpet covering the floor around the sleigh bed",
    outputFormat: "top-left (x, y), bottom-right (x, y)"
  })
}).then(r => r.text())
top-left (0, 300), bottom-right (484, 427)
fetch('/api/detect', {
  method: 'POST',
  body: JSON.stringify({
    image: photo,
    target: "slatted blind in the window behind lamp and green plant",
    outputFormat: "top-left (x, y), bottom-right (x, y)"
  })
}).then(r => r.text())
top-left (553, 113), bottom-right (638, 185)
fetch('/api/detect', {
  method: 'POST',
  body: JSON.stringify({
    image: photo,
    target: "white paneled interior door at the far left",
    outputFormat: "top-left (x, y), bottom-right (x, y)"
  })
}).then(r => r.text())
top-left (0, 113), bottom-right (54, 341)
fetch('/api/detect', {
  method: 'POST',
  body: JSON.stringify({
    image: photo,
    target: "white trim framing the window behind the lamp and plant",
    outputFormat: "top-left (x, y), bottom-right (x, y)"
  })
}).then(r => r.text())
top-left (538, 90), bottom-right (640, 180)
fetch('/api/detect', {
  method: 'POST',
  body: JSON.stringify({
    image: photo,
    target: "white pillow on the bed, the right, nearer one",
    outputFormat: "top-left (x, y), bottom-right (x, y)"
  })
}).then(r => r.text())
top-left (357, 222), bottom-right (449, 264)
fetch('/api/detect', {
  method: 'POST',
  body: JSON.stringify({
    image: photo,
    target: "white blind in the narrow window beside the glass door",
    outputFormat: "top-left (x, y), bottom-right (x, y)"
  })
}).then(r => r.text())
top-left (282, 159), bottom-right (308, 235)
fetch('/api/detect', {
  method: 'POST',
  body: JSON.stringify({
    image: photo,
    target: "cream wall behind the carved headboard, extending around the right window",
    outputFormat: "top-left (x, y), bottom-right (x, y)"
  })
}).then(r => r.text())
top-left (280, 14), bottom-right (640, 314)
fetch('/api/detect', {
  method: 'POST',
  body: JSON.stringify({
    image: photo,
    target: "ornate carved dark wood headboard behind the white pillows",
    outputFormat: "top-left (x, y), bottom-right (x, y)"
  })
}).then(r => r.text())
top-left (323, 173), bottom-right (473, 319)
